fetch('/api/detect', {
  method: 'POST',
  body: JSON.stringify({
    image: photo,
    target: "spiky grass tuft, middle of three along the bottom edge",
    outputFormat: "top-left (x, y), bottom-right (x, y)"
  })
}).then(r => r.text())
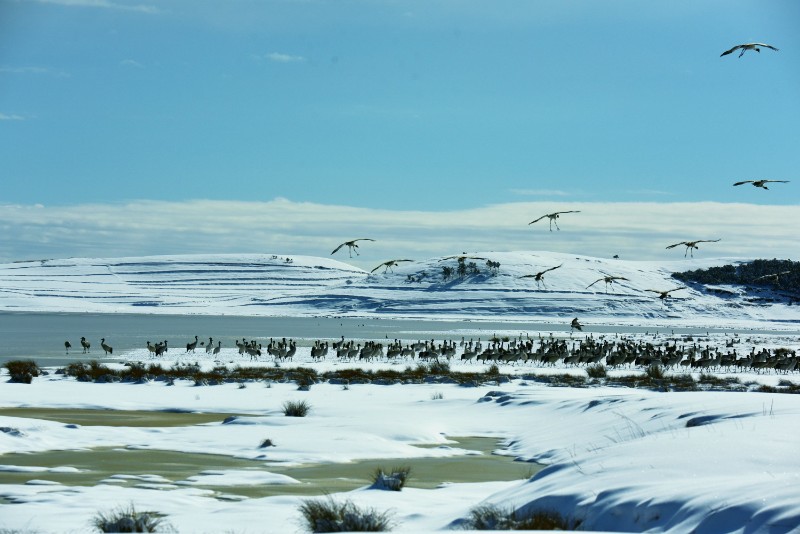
top-left (300, 497), bottom-right (392, 532)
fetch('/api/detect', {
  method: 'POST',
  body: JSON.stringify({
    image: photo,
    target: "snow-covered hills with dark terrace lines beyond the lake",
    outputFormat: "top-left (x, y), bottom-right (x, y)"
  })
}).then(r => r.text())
top-left (0, 251), bottom-right (800, 329)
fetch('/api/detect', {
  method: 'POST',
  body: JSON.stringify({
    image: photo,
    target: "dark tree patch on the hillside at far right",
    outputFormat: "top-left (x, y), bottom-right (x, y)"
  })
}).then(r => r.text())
top-left (672, 259), bottom-right (800, 294)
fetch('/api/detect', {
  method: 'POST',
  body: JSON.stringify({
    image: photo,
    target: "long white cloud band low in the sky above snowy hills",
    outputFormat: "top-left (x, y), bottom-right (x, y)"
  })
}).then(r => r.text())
top-left (0, 199), bottom-right (800, 268)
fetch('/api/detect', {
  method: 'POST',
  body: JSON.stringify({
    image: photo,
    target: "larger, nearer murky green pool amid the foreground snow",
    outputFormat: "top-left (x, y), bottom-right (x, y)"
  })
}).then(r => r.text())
top-left (0, 437), bottom-right (542, 499)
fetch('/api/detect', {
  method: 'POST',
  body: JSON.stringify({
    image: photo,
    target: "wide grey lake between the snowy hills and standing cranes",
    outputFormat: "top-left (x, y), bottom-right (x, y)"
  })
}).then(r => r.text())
top-left (0, 313), bottom-right (787, 367)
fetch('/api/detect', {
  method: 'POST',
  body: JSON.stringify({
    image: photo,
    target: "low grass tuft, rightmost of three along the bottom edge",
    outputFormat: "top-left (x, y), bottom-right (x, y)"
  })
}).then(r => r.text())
top-left (462, 504), bottom-right (581, 530)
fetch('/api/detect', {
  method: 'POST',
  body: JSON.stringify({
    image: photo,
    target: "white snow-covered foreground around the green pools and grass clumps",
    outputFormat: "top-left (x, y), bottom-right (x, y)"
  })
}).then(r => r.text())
top-left (0, 374), bottom-right (800, 532)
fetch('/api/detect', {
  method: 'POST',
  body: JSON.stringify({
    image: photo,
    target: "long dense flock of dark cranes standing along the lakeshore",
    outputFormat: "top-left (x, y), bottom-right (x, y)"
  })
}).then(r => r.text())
top-left (67, 330), bottom-right (800, 374)
